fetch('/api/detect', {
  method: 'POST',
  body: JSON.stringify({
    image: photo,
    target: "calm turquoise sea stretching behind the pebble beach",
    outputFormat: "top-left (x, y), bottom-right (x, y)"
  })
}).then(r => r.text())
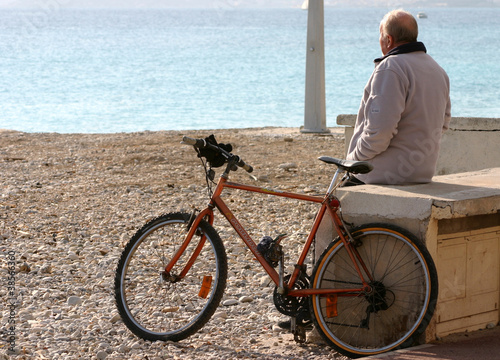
top-left (0, 8), bottom-right (500, 133)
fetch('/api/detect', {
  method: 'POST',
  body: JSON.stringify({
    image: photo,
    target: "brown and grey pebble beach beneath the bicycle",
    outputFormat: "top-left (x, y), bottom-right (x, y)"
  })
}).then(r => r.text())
top-left (0, 128), bottom-right (356, 360)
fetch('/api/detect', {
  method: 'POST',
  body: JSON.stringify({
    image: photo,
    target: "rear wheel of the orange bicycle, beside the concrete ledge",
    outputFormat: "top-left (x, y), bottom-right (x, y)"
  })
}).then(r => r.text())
top-left (310, 224), bottom-right (438, 358)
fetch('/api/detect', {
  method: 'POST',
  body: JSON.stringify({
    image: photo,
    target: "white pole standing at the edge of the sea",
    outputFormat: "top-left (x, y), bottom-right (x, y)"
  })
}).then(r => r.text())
top-left (300, 0), bottom-right (329, 133)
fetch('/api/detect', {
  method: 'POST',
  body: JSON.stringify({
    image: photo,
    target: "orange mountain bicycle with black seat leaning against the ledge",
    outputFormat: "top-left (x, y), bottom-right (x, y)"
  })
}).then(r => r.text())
top-left (115, 136), bottom-right (438, 358)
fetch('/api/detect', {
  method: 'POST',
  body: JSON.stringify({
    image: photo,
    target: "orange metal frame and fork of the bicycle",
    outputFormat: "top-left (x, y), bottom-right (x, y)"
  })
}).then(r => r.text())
top-left (165, 166), bottom-right (371, 297)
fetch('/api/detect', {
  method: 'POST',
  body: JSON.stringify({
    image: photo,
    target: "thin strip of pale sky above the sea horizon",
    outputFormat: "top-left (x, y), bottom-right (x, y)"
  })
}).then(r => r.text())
top-left (0, 0), bottom-right (500, 9)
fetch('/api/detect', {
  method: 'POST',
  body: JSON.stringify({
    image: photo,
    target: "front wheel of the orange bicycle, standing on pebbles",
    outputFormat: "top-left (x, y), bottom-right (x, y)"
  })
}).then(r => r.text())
top-left (115, 213), bottom-right (227, 341)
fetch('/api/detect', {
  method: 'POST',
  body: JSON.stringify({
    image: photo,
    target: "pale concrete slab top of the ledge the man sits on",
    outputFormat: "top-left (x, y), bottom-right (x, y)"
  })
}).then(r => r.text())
top-left (338, 168), bottom-right (500, 229)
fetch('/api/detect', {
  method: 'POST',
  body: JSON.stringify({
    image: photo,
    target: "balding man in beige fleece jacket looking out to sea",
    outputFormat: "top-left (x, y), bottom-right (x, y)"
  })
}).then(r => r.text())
top-left (346, 10), bottom-right (451, 185)
